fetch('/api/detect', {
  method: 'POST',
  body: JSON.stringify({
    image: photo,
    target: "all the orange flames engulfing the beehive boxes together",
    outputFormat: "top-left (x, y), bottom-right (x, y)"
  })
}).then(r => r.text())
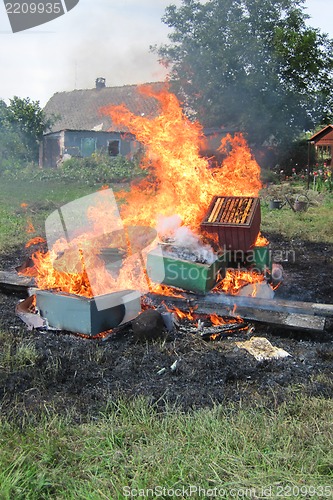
top-left (22, 87), bottom-right (264, 297)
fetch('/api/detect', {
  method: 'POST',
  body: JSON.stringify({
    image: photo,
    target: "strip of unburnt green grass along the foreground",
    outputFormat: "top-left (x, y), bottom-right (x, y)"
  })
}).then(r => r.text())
top-left (0, 398), bottom-right (333, 499)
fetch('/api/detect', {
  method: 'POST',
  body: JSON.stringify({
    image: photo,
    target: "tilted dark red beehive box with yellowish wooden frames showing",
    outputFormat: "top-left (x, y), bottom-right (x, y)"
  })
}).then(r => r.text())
top-left (201, 196), bottom-right (261, 252)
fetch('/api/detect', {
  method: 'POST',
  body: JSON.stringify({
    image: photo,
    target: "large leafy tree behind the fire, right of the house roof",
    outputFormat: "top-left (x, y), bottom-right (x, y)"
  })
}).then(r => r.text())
top-left (153, 0), bottom-right (333, 157)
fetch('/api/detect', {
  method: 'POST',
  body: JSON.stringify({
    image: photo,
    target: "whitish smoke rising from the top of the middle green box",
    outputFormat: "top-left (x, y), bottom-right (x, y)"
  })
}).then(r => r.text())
top-left (157, 215), bottom-right (217, 265)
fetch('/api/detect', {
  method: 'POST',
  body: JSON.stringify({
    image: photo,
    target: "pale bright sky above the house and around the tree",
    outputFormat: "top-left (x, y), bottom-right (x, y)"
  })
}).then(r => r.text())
top-left (0, 0), bottom-right (333, 107)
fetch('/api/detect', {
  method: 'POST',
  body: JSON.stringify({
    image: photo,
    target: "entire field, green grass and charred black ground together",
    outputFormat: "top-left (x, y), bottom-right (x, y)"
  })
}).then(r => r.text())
top-left (0, 175), bottom-right (333, 499)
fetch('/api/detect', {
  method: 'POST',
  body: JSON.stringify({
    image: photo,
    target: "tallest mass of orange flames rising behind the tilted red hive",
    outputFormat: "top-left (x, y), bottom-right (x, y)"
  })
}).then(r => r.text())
top-left (102, 87), bottom-right (261, 230)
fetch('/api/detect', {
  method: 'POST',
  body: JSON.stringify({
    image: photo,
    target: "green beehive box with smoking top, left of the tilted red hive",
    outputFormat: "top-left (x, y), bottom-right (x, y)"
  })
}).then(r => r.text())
top-left (147, 250), bottom-right (226, 294)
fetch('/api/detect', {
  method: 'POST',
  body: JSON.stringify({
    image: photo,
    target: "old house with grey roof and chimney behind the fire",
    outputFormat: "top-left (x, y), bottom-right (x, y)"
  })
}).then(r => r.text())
top-left (39, 78), bottom-right (164, 167)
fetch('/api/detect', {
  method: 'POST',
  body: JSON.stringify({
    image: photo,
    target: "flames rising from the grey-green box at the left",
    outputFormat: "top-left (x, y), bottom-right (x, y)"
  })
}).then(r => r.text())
top-left (24, 190), bottom-right (149, 298)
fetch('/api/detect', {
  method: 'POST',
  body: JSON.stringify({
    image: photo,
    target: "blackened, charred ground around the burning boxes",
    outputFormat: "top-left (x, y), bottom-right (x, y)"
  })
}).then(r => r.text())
top-left (0, 236), bottom-right (333, 420)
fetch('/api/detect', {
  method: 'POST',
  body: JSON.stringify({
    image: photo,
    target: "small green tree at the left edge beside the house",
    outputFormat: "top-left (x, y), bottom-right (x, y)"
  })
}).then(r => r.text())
top-left (0, 96), bottom-right (54, 161)
